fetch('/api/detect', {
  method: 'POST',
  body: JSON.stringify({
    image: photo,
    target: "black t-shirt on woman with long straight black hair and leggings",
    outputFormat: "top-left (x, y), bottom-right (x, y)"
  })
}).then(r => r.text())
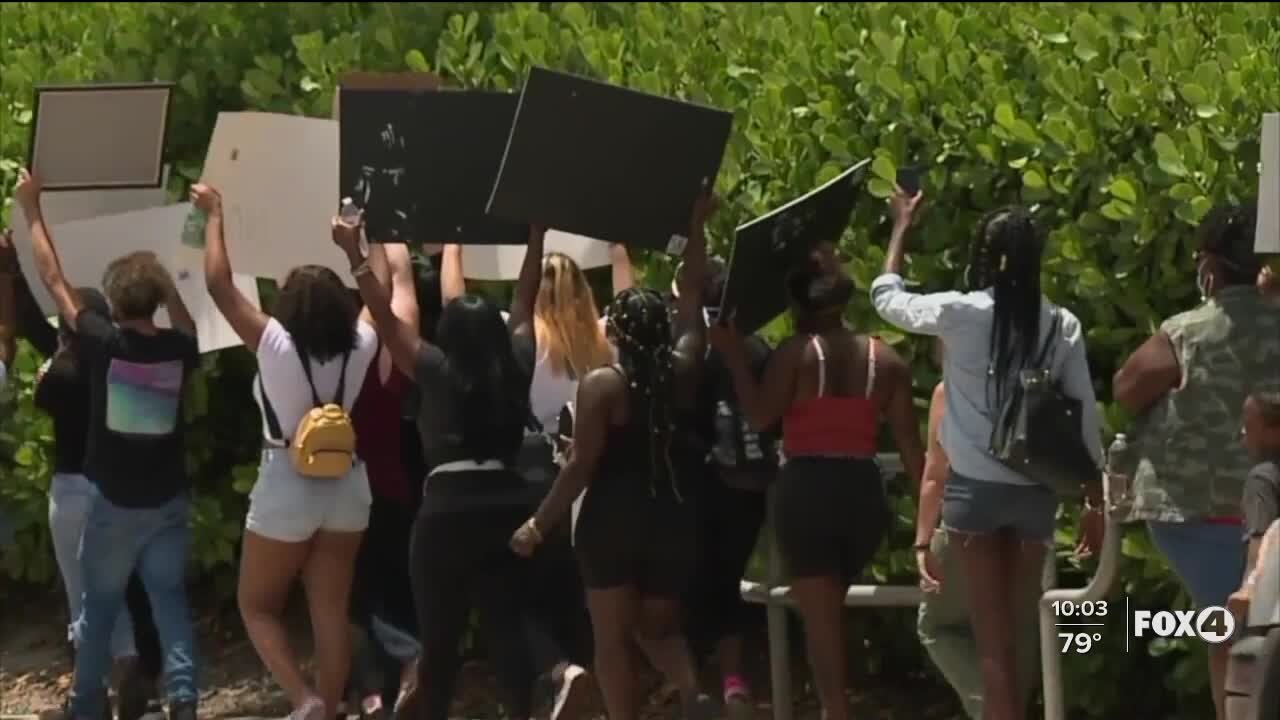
top-left (413, 333), bottom-right (538, 473)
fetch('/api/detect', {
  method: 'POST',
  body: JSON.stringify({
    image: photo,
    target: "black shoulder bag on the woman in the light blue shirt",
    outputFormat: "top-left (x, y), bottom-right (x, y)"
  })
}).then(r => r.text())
top-left (991, 310), bottom-right (1101, 498)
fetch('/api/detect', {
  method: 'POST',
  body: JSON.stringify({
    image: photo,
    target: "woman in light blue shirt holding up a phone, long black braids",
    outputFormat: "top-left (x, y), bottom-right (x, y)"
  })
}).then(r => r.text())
top-left (872, 192), bottom-right (1102, 720)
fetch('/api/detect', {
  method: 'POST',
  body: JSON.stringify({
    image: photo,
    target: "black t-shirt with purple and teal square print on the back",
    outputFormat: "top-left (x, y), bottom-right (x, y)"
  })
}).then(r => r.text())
top-left (76, 310), bottom-right (200, 507)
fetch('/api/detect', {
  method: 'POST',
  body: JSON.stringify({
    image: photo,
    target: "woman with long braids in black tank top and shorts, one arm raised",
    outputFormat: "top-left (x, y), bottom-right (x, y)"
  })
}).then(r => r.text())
top-left (511, 197), bottom-right (713, 720)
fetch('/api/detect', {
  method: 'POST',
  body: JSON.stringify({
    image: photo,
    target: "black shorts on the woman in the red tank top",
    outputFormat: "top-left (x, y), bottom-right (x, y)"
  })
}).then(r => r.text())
top-left (774, 457), bottom-right (890, 584)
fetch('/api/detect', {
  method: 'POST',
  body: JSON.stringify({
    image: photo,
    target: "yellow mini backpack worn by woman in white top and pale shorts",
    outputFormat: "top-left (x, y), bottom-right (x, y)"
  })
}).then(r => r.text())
top-left (259, 351), bottom-right (356, 479)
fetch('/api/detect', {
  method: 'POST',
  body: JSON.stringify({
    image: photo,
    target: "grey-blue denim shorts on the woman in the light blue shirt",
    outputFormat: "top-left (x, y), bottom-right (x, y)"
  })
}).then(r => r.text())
top-left (942, 471), bottom-right (1057, 543)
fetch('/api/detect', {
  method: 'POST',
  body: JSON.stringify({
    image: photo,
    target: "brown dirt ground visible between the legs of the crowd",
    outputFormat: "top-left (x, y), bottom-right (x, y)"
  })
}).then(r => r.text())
top-left (0, 589), bottom-right (959, 720)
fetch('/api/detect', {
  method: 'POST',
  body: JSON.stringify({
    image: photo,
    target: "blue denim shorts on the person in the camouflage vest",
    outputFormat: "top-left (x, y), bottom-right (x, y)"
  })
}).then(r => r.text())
top-left (1147, 521), bottom-right (1244, 607)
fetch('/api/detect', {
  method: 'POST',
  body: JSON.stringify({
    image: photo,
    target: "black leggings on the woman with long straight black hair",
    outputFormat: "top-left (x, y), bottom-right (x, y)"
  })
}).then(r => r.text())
top-left (410, 470), bottom-right (538, 720)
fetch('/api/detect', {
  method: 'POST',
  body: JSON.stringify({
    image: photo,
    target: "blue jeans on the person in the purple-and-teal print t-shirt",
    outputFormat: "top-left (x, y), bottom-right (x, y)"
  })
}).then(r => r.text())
top-left (70, 495), bottom-right (200, 717)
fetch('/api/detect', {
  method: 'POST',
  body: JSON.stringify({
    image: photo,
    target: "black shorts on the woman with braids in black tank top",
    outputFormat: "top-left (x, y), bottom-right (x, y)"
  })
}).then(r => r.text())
top-left (573, 478), bottom-right (698, 596)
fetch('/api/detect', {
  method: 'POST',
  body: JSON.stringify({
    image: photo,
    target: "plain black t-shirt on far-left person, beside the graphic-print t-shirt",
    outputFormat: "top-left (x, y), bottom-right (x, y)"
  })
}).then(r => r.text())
top-left (35, 350), bottom-right (90, 475)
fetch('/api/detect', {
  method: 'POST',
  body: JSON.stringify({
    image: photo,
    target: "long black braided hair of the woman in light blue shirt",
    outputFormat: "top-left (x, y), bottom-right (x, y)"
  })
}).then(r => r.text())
top-left (964, 206), bottom-right (1044, 405)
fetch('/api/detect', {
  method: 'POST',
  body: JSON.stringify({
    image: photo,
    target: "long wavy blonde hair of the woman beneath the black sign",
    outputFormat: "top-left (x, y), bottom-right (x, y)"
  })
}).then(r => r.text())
top-left (534, 252), bottom-right (613, 378)
